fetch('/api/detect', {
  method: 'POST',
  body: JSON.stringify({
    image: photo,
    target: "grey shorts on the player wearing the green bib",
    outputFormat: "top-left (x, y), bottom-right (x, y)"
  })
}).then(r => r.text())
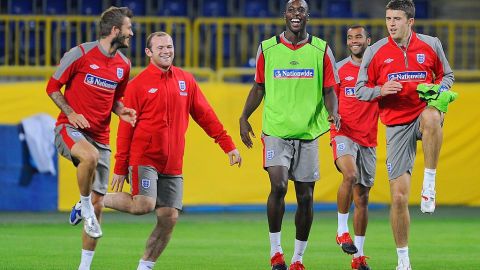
top-left (262, 134), bottom-right (320, 182)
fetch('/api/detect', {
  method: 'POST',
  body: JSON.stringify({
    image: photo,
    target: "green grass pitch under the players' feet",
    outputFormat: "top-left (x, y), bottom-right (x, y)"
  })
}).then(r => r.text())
top-left (0, 206), bottom-right (480, 270)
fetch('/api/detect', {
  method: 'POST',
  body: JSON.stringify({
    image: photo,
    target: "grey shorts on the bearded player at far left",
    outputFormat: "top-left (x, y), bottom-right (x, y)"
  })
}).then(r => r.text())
top-left (55, 124), bottom-right (112, 195)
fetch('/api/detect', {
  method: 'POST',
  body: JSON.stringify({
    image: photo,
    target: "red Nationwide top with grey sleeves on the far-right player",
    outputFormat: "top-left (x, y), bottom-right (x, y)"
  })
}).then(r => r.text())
top-left (355, 31), bottom-right (454, 126)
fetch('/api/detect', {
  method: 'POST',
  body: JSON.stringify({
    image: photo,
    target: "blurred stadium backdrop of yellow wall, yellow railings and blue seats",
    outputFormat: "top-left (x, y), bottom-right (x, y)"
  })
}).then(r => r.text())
top-left (0, 0), bottom-right (480, 210)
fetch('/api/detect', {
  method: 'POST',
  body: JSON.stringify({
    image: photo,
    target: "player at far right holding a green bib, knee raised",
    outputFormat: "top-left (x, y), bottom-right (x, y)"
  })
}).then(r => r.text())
top-left (355, 0), bottom-right (454, 270)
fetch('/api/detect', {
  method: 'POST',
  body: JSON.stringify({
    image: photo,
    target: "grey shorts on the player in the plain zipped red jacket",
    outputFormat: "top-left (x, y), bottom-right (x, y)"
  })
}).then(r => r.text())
top-left (128, 165), bottom-right (183, 210)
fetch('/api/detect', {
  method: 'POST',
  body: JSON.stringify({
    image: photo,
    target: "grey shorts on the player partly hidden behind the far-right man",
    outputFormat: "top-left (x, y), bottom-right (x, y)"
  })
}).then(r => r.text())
top-left (332, 136), bottom-right (377, 187)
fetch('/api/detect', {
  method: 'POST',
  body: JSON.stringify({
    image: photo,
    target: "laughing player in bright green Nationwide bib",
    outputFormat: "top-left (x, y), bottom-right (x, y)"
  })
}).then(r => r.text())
top-left (240, 0), bottom-right (339, 270)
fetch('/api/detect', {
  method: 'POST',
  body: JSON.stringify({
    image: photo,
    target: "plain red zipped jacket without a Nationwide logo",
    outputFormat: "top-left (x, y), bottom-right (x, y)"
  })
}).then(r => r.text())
top-left (114, 64), bottom-right (235, 175)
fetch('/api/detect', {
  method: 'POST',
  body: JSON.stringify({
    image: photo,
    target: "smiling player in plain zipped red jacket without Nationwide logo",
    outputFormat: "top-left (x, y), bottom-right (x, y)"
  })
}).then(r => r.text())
top-left (105, 32), bottom-right (242, 270)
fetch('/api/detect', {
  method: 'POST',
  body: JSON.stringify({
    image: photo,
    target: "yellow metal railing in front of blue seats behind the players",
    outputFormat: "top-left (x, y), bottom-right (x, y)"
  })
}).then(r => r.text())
top-left (0, 15), bottom-right (480, 82)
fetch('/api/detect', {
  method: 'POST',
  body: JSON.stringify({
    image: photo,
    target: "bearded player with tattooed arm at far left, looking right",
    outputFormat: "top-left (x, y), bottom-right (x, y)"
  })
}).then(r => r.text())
top-left (46, 7), bottom-right (136, 270)
